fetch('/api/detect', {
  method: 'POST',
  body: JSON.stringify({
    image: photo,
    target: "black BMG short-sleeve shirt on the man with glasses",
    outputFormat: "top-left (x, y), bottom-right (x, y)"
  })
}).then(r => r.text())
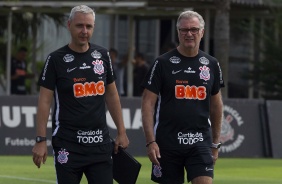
top-left (142, 49), bottom-right (224, 149)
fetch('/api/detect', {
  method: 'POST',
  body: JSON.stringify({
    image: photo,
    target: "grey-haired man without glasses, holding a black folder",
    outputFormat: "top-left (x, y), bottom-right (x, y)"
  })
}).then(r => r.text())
top-left (32, 5), bottom-right (129, 184)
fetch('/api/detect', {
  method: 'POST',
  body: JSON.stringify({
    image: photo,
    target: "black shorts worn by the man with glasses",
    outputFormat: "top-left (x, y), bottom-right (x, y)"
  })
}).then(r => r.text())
top-left (151, 146), bottom-right (214, 184)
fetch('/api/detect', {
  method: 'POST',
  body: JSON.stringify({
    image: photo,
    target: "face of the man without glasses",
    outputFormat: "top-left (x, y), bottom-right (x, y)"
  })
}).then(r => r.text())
top-left (68, 12), bottom-right (94, 46)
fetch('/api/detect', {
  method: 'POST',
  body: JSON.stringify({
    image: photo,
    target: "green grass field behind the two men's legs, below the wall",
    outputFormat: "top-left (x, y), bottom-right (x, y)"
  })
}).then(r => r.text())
top-left (0, 156), bottom-right (282, 184)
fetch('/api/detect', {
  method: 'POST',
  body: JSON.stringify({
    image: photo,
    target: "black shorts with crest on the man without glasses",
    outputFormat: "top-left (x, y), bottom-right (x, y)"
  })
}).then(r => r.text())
top-left (53, 140), bottom-right (113, 184)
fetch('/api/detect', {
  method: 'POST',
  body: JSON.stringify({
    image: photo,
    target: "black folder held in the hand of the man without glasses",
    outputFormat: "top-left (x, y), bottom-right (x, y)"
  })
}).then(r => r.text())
top-left (113, 148), bottom-right (141, 184)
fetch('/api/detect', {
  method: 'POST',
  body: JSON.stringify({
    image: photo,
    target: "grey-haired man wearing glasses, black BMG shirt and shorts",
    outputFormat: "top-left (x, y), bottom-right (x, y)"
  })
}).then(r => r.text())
top-left (142, 11), bottom-right (224, 184)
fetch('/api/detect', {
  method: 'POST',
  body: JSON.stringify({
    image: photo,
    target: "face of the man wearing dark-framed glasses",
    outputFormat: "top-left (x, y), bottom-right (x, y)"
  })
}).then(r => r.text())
top-left (177, 17), bottom-right (204, 50)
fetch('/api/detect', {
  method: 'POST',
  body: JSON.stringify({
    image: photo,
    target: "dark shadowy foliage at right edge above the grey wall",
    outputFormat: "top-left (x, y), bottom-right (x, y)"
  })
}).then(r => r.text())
top-left (250, 9), bottom-right (282, 100)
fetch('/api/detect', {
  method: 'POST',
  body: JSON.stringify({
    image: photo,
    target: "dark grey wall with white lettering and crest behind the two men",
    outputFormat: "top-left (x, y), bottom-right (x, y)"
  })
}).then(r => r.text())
top-left (0, 96), bottom-right (282, 158)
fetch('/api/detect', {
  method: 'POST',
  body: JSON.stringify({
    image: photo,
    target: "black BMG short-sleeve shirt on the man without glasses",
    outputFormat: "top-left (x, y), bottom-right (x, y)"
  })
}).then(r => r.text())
top-left (38, 44), bottom-right (115, 146)
